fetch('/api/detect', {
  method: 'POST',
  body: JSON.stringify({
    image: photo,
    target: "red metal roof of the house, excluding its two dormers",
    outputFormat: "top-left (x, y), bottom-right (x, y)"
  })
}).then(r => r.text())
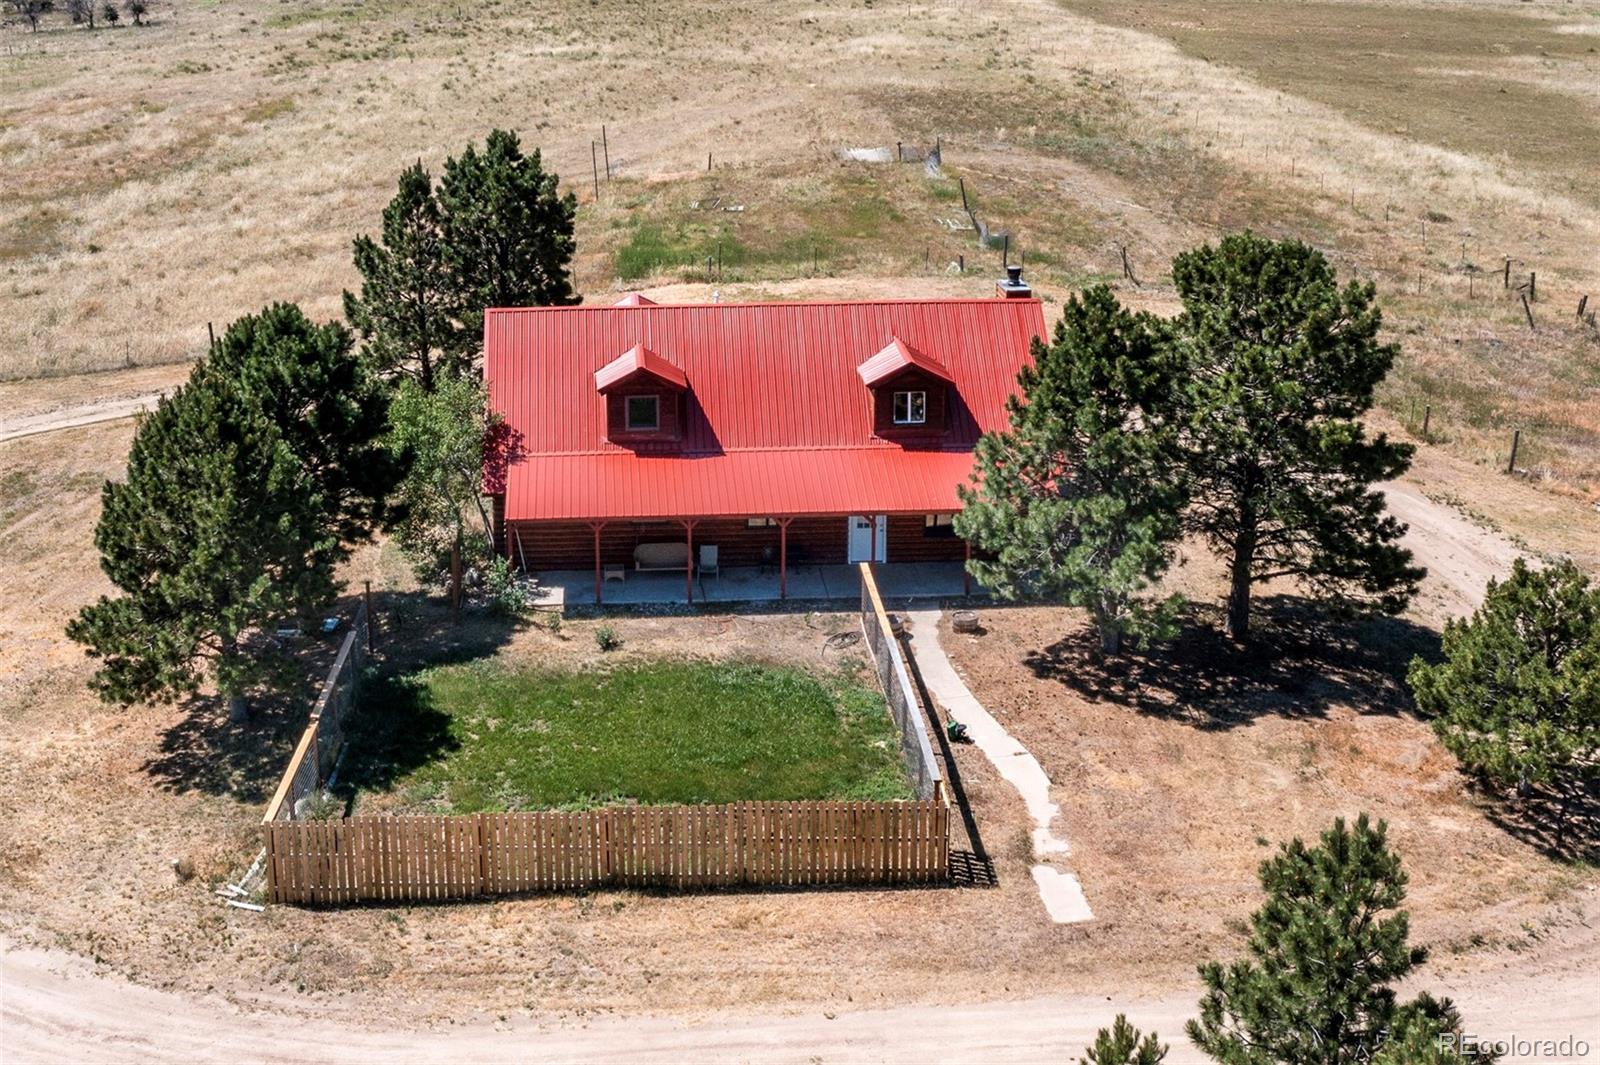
top-left (483, 299), bottom-right (1045, 521)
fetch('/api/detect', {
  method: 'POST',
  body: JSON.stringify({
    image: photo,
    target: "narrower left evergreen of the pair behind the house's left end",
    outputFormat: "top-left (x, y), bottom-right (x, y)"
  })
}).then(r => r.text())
top-left (344, 162), bottom-right (460, 392)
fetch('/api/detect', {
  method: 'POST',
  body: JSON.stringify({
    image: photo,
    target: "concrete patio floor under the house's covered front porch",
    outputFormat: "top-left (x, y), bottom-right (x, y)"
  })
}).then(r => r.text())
top-left (534, 561), bottom-right (982, 609)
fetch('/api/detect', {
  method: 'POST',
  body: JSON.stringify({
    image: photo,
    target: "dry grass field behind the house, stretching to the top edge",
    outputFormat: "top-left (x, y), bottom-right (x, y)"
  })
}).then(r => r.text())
top-left (0, 0), bottom-right (1600, 497)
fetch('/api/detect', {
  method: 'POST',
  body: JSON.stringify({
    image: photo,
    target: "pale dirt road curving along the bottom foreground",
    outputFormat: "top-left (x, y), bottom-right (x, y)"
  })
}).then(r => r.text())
top-left (0, 907), bottom-right (1600, 1065)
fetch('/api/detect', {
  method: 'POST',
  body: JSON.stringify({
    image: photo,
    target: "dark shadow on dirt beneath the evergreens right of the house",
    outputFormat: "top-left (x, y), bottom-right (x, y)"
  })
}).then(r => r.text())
top-left (1024, 595), bottom-right (1440, 731)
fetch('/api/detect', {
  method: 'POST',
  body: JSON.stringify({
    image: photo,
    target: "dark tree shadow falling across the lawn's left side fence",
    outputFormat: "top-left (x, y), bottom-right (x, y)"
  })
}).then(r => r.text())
top-left (142, 592), bottom-right (518, 803)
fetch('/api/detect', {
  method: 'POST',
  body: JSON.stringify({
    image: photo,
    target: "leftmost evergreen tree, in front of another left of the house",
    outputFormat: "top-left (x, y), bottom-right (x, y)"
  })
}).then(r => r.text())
top-left (67, 371), bottom-right (336, 721)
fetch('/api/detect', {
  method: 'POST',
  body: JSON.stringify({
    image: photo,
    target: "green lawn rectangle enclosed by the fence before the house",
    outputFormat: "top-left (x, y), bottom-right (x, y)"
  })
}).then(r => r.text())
top-left (342, 662), bottom-right (914, 814)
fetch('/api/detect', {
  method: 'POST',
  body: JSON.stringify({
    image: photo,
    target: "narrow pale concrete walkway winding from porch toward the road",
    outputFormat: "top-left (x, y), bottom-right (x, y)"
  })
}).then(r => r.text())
top-left (906, 611), bottom-right (1094, 924)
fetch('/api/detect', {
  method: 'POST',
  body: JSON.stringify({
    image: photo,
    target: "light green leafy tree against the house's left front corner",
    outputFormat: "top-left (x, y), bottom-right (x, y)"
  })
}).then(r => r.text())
top-left (389, 377), bottom-right (502, 604)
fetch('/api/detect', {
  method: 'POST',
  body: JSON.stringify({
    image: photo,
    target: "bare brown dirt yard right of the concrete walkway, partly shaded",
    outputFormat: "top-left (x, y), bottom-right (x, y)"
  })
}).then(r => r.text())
top-left (942, 588), bottom-right (1594, 997)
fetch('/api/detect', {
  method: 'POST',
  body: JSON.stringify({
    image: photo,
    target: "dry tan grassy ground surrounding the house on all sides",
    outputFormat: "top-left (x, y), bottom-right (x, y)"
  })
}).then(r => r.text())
top-left (0, 0), bottom-right (1600, 1025)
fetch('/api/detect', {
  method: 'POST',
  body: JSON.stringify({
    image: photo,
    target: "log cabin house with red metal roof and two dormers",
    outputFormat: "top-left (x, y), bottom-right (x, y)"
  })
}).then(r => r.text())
top-left (483, 269), bottom-right (1045, 603)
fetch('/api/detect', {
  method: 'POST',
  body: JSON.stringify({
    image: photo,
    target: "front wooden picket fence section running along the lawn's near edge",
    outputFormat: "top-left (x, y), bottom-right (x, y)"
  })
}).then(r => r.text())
top-left (264, 800), bottom-right (950, 903)
